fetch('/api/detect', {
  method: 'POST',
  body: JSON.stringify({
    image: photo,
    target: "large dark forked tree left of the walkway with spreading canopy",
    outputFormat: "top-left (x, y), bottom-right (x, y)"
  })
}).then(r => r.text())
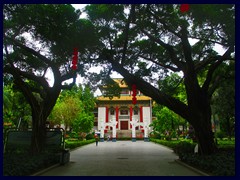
top-left (3, 4), bottom-right (95, 153)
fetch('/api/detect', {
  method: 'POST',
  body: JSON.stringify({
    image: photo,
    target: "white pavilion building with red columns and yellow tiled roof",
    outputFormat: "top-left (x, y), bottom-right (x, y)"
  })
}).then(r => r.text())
top-left (94, 79), bottom-right (152, 142)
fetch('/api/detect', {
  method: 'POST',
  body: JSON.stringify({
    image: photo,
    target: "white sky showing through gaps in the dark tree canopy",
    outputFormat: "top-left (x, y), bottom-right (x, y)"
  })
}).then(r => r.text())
top-left (47, 4), bottom-right (226, 96)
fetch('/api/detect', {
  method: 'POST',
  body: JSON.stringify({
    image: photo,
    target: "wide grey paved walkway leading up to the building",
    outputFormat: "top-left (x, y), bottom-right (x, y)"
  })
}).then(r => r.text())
top-left (39, 141), bottom-right (204, 176)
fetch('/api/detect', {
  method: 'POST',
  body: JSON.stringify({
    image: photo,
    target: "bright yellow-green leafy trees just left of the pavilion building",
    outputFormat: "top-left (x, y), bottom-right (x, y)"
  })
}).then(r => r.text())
top-left (49, 85), bottom-right (95, 133)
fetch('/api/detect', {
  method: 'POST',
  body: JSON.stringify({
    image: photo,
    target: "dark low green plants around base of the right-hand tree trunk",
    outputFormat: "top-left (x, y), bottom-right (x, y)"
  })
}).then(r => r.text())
top-left (150, 138), bottom-right (235, 176)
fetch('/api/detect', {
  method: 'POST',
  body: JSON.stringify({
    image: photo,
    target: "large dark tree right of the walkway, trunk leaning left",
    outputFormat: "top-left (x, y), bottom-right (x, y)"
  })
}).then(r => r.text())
top-left (83, 4), bottom-right (235, 154)
